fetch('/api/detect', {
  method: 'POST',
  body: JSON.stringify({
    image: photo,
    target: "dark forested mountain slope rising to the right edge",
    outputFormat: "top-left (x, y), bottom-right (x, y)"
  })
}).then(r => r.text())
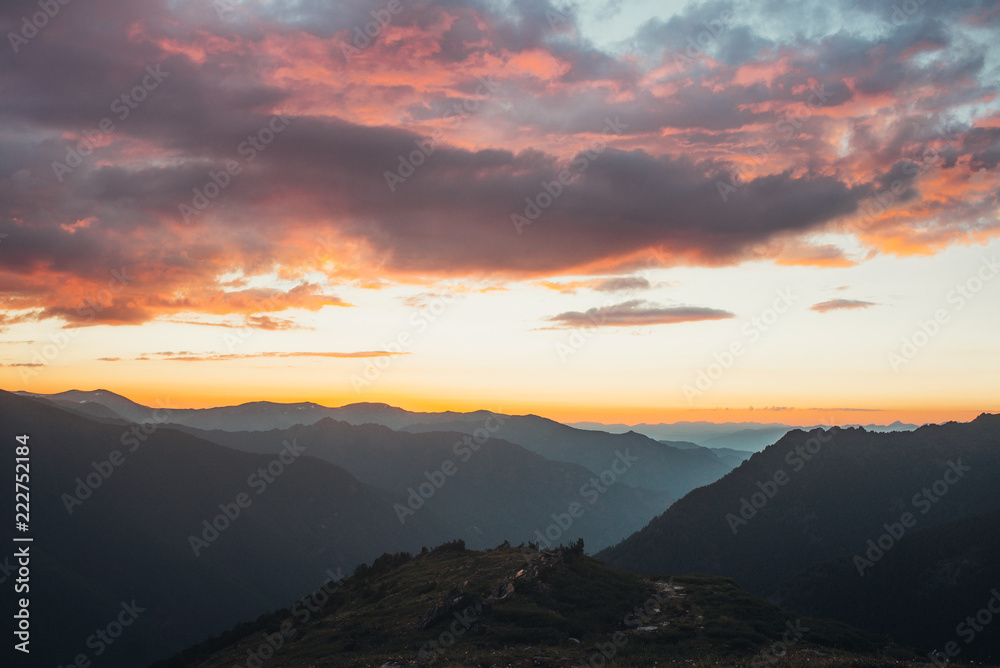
top-left (598, 415), bottom-right (1000, 660)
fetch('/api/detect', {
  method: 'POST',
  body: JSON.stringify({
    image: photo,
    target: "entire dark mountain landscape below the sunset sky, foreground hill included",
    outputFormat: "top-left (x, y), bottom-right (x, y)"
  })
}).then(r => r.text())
top-left (0, 390), bottom-right (1000, 668)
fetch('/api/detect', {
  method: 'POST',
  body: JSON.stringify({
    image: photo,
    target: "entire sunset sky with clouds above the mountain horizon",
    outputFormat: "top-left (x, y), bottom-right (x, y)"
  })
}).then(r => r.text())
top-left (0, 0), bottom-right (1000, 425)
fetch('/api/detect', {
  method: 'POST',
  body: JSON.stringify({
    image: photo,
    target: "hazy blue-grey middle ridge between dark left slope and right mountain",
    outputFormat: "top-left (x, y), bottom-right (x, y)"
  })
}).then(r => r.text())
top-left (174, 413), bottom-right (676, 549)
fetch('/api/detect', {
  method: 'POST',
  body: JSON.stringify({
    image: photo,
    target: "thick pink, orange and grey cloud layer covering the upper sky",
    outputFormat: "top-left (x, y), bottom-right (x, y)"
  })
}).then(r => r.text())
top-left (0, 0), bottom-right (1000, 329)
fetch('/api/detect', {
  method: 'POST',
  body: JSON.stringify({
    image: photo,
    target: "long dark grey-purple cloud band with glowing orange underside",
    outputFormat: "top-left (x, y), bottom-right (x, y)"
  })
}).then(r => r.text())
top-left (0, 110), bottom-right (869, 277)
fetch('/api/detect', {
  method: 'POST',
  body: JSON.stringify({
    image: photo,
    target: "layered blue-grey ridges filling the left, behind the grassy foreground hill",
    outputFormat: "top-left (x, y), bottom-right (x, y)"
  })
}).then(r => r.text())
top-left (0, 391), bottom-right (725, 666)
